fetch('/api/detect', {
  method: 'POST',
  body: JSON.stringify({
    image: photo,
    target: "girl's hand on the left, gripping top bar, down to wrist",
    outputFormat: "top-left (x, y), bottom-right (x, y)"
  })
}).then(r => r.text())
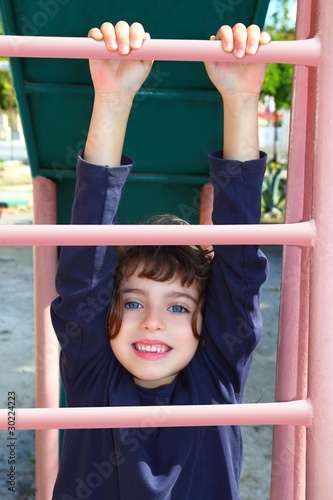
top-left (88, 21), bottom-right (152, 98)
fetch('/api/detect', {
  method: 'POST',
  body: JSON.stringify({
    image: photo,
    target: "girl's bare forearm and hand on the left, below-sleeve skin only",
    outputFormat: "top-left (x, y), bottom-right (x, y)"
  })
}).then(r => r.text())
top-left (84, 21), bottom-right (152, 167)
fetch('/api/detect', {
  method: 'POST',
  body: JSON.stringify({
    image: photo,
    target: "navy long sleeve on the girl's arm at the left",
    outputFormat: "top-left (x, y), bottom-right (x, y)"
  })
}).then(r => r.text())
top-left (51, 152), bottom-right (133, 402)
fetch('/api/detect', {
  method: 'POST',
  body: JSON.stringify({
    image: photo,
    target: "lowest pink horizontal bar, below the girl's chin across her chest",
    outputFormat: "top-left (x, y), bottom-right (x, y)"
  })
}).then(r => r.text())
top-left (0, 400), bottom-right (313, 431)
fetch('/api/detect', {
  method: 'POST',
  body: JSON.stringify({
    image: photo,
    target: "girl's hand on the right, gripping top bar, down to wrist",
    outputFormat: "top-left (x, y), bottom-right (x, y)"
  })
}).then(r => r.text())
top-left (205, 23), bottom-right (270, 97)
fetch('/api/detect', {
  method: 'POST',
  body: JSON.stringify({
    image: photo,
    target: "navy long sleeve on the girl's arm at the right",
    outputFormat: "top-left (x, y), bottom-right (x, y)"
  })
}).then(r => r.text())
top-left (198, 152), bottom-right (267, 402)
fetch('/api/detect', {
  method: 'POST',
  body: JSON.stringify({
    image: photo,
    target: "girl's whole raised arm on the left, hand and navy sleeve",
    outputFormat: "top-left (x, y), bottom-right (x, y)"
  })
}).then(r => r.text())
top-left (51, 22), bottom-right (151, 394)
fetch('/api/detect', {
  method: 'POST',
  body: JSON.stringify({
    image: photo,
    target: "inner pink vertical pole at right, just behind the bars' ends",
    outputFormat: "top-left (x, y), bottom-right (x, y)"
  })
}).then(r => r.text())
top-left (271, 0), bottom-right (316, 500)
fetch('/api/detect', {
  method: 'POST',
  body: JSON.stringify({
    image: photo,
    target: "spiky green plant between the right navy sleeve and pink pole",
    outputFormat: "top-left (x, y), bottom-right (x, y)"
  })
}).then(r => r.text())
top-left (261, 162), bottom-right (287, 218)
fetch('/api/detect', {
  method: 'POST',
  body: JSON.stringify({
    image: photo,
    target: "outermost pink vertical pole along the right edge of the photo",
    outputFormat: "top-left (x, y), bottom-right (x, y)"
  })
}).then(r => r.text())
top-left (306, 0), bottom-right (333, 500)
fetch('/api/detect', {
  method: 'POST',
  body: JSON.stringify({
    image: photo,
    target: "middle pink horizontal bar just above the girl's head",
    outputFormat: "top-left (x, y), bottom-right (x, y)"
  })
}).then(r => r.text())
top-left (0, 220), bottom-right (316, 246)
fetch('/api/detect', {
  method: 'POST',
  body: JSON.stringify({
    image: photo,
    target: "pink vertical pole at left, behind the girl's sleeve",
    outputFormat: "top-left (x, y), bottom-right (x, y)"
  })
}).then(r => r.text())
top-left (33, 177), bottom-right (59, 500)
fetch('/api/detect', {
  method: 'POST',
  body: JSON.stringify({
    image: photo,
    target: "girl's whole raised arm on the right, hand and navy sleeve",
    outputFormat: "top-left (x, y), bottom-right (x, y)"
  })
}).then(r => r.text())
top-left (198, 24), bottom-right (269, 403)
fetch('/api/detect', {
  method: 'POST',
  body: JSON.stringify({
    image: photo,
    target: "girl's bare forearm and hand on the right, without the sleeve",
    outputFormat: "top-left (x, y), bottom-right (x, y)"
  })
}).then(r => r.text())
top-left (206, 23), bottom-right (270, 161)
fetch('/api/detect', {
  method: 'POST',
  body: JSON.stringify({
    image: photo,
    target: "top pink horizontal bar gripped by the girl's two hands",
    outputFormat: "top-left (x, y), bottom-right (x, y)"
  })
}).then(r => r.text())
top-left (0, 35), bottom-right (320, 66)
